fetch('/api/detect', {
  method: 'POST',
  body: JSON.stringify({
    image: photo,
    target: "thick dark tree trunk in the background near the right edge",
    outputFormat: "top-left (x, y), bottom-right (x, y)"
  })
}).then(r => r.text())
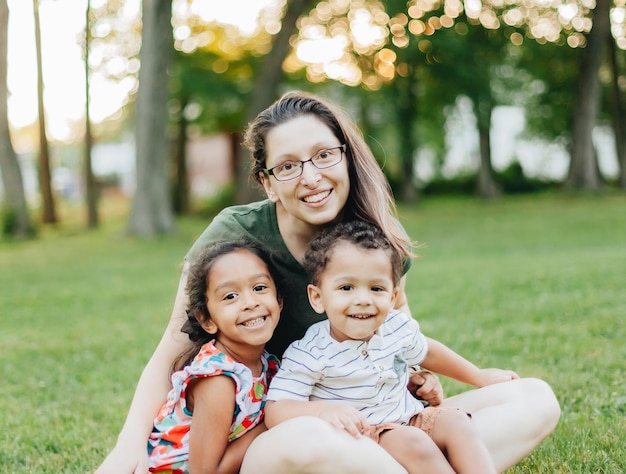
top-left (565, 0), bottom-right (611, 190)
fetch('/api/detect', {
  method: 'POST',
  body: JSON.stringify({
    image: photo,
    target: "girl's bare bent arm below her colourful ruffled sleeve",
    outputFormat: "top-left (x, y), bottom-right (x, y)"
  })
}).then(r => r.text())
top-left (188, 375), bottom-right (266, 474)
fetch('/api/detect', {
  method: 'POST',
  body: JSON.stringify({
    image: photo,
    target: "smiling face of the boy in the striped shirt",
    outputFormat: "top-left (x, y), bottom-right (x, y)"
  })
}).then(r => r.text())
top-left (308, 242), bottom-right (398, 342)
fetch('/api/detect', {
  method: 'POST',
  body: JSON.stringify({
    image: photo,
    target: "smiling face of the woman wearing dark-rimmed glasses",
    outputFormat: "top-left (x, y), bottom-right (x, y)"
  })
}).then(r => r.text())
top-left (261, 115), bottom-right (350, 226)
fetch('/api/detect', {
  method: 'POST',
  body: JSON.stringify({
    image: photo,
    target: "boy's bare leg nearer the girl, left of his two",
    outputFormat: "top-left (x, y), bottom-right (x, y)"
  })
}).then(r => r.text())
top-left (378, 426), bottom-right (454, 474)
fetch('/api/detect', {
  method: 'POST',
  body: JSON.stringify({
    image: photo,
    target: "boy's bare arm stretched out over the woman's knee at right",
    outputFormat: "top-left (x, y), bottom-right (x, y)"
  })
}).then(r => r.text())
top-left (421, 338), bottom-right (519, 387)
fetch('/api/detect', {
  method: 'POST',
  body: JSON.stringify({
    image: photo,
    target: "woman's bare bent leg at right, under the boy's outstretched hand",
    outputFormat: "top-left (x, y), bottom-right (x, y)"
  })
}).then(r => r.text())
top-left (442, 378), bottom-right (561, 472)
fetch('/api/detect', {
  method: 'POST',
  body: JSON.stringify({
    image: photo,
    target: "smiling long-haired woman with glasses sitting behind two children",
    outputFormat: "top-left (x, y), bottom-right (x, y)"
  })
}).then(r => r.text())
top-left (98, 92), bottom-right (560, 474)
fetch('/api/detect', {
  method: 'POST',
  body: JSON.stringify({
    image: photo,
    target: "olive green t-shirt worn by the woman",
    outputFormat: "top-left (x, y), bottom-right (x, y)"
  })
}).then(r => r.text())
top-left (185, 199), bottom-right (410, 357)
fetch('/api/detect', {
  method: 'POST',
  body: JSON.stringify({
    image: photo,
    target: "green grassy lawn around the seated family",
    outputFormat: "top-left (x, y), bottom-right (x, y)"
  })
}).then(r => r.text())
top-left (0, 191), bottom-right (626, 473)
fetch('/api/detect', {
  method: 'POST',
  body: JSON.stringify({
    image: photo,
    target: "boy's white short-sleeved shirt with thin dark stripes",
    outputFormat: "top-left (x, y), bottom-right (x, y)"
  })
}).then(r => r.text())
top-left (267, 310), bottom-right (428, 425)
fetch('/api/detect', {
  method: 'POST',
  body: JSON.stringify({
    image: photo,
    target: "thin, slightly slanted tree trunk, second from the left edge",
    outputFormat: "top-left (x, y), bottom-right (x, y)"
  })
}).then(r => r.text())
top-left (33, 0), bottom-right (57, 224)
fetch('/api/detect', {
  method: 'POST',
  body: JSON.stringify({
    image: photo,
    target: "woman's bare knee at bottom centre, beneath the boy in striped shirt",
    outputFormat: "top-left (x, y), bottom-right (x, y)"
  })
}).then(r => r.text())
top-left (239, 416), bottom-right (406, 474)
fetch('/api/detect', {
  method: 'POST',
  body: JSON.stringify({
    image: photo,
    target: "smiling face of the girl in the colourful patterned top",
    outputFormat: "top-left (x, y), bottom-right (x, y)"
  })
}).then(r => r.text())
top-left (202, 250), bottom-right (282, 347)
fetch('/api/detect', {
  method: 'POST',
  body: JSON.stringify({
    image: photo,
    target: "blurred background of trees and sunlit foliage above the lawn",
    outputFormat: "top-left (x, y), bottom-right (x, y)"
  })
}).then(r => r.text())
top-left (0, 0), bottom-right (626, 236)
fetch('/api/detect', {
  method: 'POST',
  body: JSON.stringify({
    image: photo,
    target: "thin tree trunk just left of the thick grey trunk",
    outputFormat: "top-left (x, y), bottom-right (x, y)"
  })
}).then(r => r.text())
top-left (83, 0), bottom-right (98, 229)
